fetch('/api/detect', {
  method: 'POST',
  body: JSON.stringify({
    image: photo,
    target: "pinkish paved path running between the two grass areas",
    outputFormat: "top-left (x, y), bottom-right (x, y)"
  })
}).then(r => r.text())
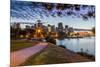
top-left (10, 43), bottom-right (47, 67)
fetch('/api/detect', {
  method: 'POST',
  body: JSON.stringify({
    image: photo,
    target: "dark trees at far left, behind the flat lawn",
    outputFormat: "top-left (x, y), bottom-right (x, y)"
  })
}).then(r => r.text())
top-left (10, 23), bottom-right (35, 39)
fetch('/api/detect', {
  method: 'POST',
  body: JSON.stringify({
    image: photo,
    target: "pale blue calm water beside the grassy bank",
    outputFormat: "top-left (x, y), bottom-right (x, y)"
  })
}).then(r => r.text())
top-left (56, 37), bottom-right (95, 55)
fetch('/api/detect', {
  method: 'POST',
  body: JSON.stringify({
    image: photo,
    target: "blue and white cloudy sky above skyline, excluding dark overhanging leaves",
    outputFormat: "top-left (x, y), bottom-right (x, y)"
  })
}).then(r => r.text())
top-left (11, 0), bottom-right (95, 29)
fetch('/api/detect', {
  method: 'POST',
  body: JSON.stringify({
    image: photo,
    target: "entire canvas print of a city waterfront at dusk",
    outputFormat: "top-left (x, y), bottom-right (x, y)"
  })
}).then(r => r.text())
top-left (10, 1), bottom-right (96, 67)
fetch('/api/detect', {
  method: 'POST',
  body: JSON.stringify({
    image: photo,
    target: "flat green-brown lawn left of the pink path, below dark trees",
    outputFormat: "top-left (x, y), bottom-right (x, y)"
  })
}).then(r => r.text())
top-left (10, 40), bottom-right (38, 52)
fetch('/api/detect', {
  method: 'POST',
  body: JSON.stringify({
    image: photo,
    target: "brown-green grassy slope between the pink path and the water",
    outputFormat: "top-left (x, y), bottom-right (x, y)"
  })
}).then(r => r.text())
top-left (22, 44), bottom-right (91, 65)
